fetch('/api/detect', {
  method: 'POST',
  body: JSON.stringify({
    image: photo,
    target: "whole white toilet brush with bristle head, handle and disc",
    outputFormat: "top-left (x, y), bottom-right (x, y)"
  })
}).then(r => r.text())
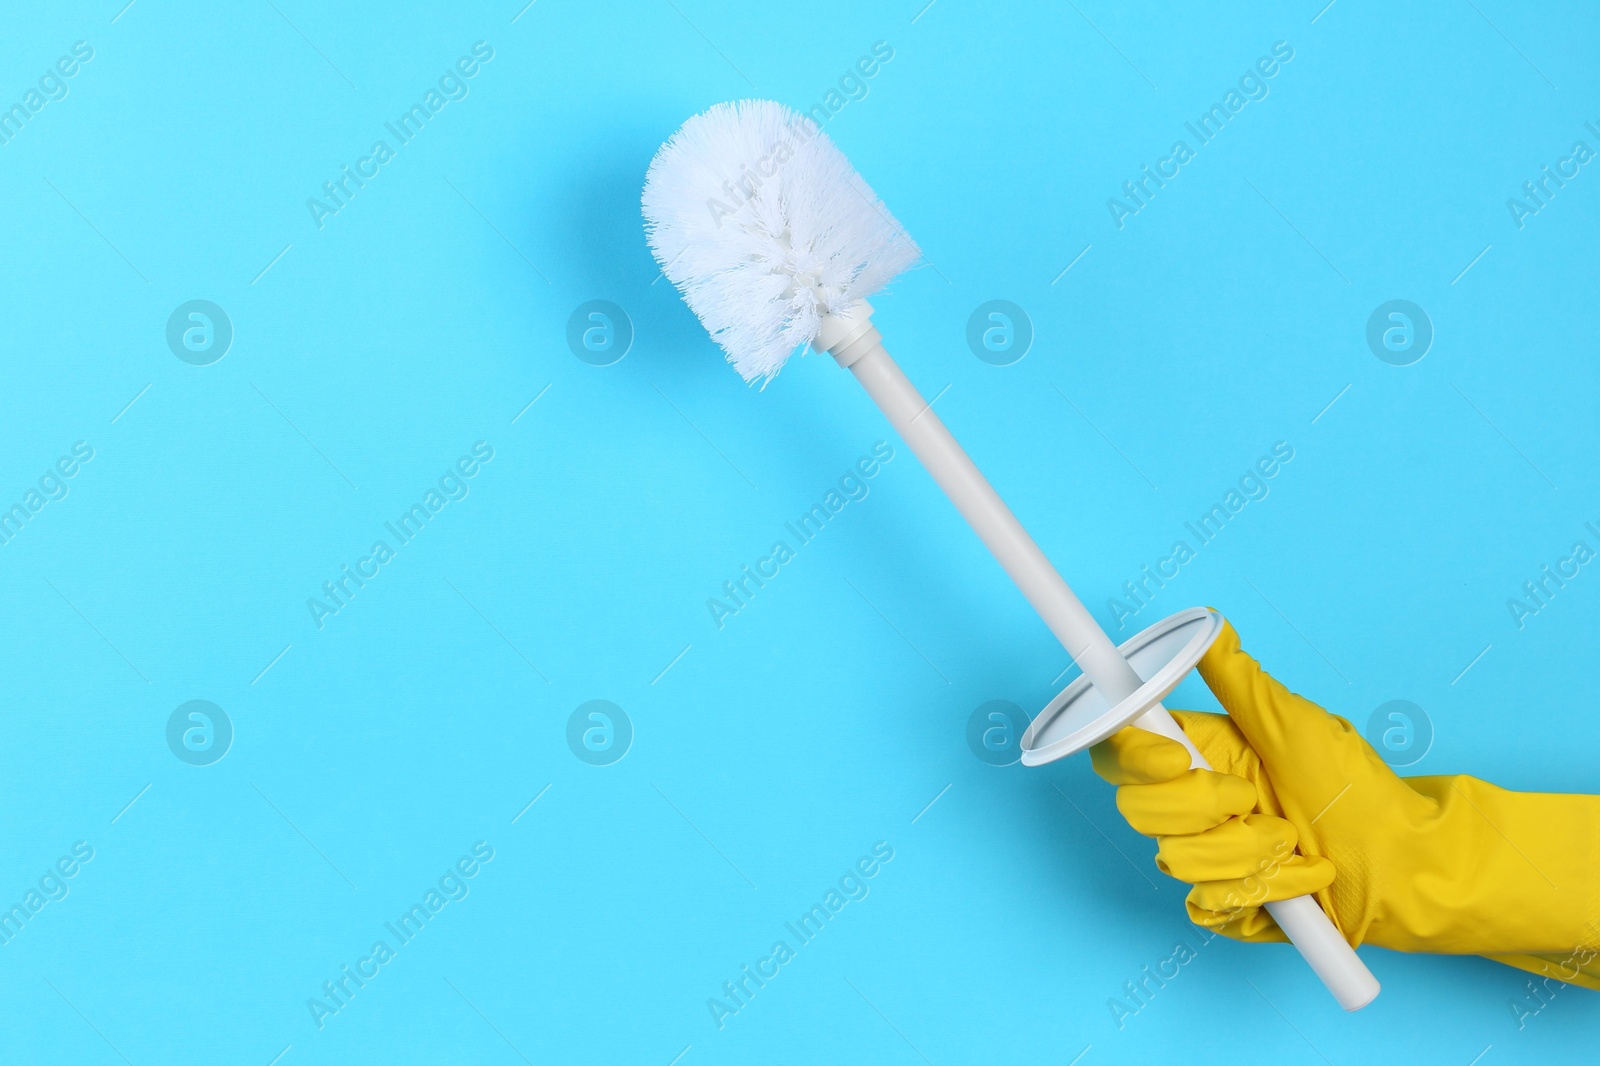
top-left (643, 101), bottom-right (1378, 1010)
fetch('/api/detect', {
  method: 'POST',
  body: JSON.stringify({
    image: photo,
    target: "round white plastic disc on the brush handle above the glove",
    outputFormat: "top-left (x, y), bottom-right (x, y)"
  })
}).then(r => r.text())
top-left (1022, 607), bottom-right (1222, 767)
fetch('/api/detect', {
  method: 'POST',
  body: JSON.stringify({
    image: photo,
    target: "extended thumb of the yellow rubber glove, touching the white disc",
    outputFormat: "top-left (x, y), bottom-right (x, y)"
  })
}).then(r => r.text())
top-left (1198, 623), bottom-right (1398, 820)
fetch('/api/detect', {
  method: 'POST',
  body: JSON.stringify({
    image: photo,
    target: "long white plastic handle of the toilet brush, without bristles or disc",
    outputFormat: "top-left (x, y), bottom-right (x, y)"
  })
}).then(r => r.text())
top-left (816, 301), bottom-right (1378, 1010)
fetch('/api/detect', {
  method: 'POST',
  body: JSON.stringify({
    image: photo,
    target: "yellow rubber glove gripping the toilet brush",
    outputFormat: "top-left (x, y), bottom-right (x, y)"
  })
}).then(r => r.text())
top-left (1093, 614), bottom-right (1600, 989)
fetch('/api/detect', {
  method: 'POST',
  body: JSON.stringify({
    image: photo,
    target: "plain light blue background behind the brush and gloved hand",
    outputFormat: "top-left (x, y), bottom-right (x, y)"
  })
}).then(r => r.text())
top-left (0, 0), bottom-right (1600, 1066)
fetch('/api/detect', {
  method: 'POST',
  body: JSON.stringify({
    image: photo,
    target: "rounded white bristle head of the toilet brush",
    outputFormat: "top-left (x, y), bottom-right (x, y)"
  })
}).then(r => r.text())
top-left (643, 99), bottom-right (922, 384)
